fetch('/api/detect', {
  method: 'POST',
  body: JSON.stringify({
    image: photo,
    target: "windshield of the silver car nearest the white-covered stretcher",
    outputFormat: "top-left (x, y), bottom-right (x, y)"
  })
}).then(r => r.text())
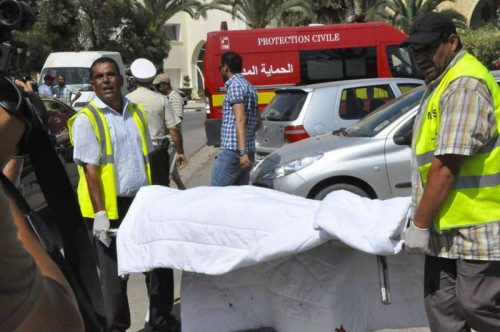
top-left (342, 87), bottom-right (425, 137)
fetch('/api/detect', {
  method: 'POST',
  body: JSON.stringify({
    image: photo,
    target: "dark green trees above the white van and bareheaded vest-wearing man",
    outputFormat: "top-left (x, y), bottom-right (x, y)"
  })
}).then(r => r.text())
top-left (7, 0), bottom-right (205, 72)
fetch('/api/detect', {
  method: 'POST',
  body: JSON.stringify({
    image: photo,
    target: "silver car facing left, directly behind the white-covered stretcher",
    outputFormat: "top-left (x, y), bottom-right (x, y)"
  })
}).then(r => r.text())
top-left (251, 71), bottom-right (500, 200)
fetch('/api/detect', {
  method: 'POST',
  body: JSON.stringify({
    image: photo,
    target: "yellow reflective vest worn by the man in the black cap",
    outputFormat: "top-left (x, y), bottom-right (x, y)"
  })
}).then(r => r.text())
top-left (415, 53), bottom-right (500, 232)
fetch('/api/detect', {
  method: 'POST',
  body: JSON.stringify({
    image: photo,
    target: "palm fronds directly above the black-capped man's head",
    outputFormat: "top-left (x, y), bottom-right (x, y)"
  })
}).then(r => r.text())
top-left (371, 0), bottom-right (468, 32)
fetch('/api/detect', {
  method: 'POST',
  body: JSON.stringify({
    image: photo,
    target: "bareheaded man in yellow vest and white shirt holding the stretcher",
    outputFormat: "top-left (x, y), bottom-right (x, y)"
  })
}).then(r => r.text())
top-left (68, 57), bottom-right (153, 331)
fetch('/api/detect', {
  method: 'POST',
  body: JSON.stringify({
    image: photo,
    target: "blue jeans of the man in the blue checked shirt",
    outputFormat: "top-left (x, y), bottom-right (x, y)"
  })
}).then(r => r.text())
top-left (212, 150), bottom-right (255, 187)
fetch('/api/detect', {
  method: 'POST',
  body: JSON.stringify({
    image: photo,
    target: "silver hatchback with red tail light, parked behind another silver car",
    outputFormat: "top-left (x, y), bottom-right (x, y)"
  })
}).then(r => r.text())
top-left (256, 78), bottom-right (424, 160)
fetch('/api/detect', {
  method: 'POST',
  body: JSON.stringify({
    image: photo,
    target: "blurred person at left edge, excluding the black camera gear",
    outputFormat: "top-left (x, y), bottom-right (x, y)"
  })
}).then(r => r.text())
top-left (0, 96), bottom-right (83, 331)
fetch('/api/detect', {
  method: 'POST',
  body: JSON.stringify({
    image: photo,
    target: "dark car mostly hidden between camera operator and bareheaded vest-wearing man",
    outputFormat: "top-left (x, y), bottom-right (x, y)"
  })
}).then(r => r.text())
top-left (21, 96), bottom-right (78, 211)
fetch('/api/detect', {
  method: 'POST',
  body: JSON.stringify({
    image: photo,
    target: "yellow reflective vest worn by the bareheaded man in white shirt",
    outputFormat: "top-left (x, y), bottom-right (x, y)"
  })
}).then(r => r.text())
top-left (68, 102), bottom-right (151, 219)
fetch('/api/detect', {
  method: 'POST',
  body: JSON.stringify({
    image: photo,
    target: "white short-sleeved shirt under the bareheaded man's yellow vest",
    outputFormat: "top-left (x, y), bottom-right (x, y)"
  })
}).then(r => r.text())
top-left (73, 96), bottom-right (153, 197)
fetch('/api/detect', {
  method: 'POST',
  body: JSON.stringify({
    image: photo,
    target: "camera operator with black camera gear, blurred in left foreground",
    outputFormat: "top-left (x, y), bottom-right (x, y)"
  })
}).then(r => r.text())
top-left (0, 0), bottom-right (106, 332)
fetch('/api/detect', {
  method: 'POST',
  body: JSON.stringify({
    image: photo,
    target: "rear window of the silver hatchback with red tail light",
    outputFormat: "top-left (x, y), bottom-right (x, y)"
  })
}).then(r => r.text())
top-left (262, 90), bottom-right (307, 121)
